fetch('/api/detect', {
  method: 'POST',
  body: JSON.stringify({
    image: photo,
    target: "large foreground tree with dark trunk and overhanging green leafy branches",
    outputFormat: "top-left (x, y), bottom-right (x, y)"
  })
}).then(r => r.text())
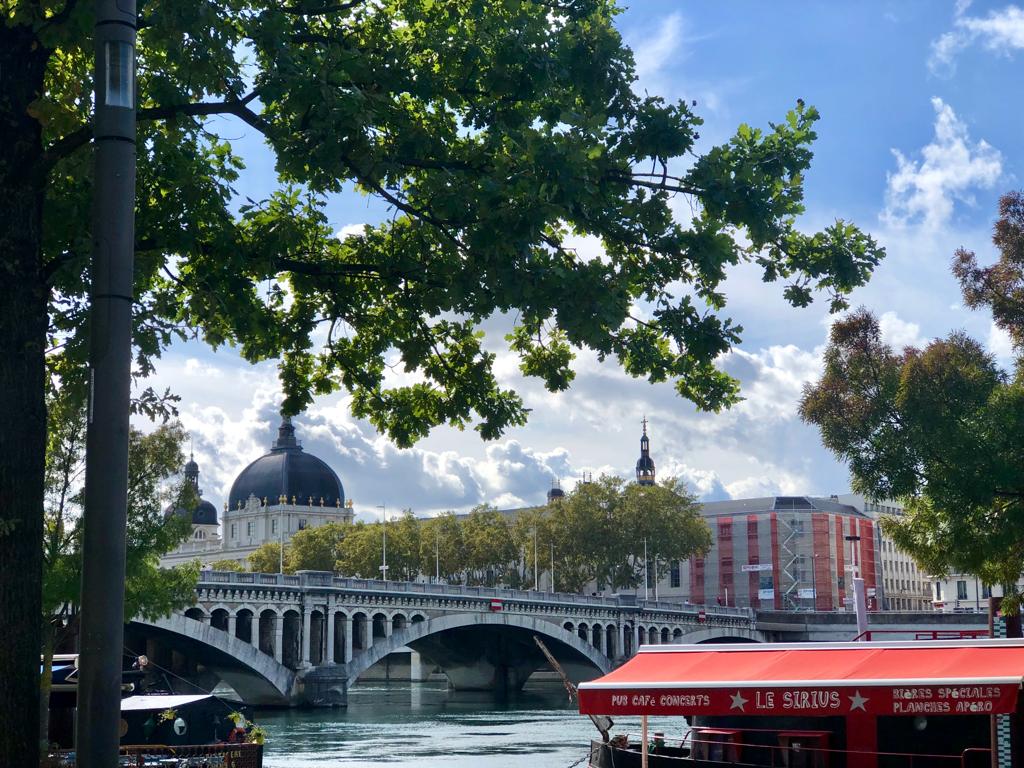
top-left (0, 0), bottom-right (881, 768)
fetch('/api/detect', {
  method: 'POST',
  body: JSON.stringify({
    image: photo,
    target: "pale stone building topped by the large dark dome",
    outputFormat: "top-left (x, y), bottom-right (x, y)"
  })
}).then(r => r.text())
top-left (162, 416), bottom-right (352, 565)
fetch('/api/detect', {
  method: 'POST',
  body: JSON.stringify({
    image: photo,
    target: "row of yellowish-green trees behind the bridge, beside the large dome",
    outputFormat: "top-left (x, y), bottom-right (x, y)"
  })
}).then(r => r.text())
top-left (244, 476), bottom-right (711, 592)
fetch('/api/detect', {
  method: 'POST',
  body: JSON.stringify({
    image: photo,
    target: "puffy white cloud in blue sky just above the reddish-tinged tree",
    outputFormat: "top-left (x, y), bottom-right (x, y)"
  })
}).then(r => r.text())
top-left (882, 97), bottom-right (1002, 229)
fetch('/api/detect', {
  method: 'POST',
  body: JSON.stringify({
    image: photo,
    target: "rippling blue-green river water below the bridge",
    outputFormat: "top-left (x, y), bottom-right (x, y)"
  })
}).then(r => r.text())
top-left (256, 683), bottom-right (684, 768)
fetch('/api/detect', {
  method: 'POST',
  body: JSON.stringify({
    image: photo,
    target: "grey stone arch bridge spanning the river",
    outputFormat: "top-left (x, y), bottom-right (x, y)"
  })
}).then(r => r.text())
top-left (126, 570), bottom-right (984, 706)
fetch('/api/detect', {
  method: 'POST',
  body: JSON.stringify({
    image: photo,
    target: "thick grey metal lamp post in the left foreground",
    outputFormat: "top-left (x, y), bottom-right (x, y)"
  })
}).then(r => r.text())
top-left (77, 0), bottom-right (136, 768)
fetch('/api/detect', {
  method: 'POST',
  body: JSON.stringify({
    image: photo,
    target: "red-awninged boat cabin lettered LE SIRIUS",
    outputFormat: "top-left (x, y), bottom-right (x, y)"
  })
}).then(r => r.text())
top-left (579, 639), bottom-right (1024, 768)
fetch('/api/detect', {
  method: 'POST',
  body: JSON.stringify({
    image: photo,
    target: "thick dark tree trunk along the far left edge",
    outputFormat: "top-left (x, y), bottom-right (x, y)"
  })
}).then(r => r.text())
top-left (0, 25), bottom-right (48, 768)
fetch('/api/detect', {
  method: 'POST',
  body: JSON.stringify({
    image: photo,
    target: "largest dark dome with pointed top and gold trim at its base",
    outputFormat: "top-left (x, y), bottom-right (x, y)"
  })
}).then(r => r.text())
top-left (227, 418), bottom-right (345, 509)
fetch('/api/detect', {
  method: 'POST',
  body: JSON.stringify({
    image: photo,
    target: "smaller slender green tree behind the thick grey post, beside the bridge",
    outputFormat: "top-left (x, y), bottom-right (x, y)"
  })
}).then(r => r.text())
top-left (39, 392), bottom-right (199, 748)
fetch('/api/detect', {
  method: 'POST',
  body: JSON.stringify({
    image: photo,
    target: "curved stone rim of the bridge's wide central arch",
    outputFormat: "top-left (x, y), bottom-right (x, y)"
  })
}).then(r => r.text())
top-left (345, 613), bottom-right (612, 684)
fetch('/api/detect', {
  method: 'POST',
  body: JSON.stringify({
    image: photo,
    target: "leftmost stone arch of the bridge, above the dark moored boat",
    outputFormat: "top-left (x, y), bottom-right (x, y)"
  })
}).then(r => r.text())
top-left (132, 613), bottom-right (296, 705)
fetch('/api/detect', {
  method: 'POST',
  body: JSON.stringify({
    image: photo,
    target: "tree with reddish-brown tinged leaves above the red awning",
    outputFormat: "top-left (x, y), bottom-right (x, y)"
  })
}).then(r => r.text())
top-left (801, 193), bottom-right (1024, 610)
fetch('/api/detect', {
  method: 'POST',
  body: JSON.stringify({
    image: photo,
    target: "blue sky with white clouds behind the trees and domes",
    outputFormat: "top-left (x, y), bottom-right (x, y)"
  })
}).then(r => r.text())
top-left (138, 0), bottom-right (1024, 518)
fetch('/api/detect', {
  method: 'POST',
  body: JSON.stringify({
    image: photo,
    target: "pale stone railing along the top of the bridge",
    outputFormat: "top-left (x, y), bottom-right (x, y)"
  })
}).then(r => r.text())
top-left (200, 570), bottom-right (754, 621)
